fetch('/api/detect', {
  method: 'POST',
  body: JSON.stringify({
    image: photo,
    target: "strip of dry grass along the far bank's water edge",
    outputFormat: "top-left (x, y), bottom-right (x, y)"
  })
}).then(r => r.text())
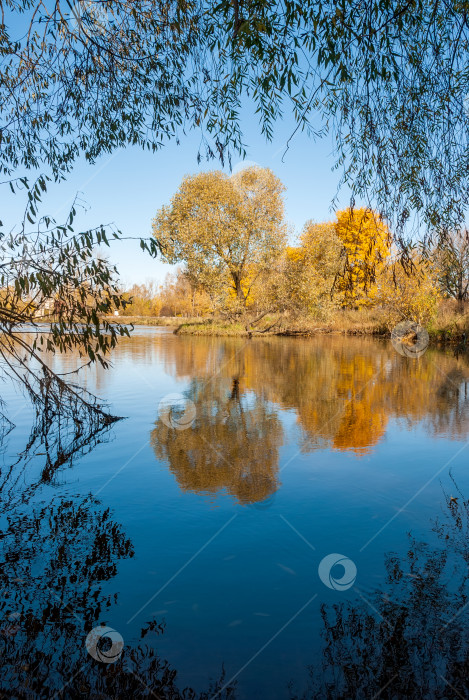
top-left (106, 300), bottom-right (469, 347)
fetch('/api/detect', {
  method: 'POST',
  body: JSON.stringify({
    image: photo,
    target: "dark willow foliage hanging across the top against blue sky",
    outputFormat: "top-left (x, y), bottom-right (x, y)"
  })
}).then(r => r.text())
top-left (0, 0), bottom-right (469, 426)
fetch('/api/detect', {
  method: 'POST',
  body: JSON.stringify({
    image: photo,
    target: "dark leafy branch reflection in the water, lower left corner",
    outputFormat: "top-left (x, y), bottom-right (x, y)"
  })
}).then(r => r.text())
top-left (0, 412), bottom-right (233, 700)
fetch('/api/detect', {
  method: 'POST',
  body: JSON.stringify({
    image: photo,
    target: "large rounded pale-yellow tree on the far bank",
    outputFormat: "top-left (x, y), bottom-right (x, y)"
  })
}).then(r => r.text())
top-left (153, 167), bottom-right (286, 309)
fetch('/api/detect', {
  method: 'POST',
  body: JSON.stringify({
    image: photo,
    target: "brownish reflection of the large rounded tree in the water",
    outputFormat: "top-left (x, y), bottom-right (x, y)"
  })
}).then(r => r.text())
top-left (151, 375), bottom-right (283, 505)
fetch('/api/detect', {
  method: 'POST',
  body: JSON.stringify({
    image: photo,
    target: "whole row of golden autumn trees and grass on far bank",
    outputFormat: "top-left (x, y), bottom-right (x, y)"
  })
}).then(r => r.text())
top-left (118, 166), bottom-right (469, 346)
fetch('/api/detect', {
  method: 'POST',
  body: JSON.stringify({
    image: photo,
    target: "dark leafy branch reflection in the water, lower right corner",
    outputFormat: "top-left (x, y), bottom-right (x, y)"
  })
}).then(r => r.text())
top-left (291, 476), bottom-right (469, 700)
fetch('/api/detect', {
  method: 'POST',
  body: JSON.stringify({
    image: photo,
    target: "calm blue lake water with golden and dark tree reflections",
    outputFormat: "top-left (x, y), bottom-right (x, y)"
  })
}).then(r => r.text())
top-left (0, 328), bottom-right (469, 699)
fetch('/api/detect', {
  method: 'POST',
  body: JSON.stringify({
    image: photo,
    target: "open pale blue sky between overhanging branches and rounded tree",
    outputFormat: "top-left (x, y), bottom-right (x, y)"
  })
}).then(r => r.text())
top-left (2, 110), bottom-right (348, 286)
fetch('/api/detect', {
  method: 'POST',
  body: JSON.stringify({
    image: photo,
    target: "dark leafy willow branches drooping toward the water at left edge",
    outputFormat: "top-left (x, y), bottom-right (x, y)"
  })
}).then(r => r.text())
top-left (0, 177), bottom-right (154, 448)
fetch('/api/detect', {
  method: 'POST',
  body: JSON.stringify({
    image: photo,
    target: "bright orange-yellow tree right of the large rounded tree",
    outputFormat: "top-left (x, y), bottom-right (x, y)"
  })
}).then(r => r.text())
top-left (335, 208), bottom-right (391, 307)
